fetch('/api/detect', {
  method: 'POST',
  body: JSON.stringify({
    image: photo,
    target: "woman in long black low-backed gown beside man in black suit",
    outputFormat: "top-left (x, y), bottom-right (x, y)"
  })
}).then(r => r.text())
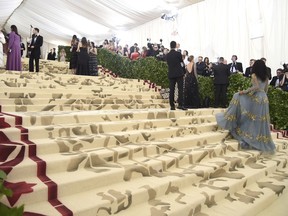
top-left (184, 55), bottom-right (200, 108)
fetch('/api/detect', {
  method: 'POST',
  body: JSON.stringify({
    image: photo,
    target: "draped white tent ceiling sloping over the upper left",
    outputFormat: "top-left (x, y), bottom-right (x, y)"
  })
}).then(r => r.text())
top-left (0, 0), bottom-right (200, 44)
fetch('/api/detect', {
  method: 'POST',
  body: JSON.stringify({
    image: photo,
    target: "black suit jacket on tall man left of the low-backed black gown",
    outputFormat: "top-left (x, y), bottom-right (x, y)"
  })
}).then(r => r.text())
top-left (166, 49), bottom-right (185, 79)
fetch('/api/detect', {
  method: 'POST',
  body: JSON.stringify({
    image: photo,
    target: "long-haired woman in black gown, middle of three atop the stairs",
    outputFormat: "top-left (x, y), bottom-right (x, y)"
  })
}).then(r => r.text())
top-left (76, 37), bottom-right (89, 75)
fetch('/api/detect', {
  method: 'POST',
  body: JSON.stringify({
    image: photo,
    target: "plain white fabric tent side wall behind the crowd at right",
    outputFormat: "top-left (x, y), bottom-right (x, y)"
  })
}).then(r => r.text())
top-left (124, 0), bottom-right (288, 74)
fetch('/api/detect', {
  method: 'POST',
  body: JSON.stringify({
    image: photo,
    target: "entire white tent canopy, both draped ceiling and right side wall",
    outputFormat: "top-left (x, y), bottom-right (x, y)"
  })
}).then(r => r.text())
top-left (0, 0), bottom-right (288, 73)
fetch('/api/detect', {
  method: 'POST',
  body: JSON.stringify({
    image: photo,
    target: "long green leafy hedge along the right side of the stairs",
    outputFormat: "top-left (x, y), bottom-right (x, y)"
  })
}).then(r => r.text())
top-left (98, 49), bottom-right (288, 130)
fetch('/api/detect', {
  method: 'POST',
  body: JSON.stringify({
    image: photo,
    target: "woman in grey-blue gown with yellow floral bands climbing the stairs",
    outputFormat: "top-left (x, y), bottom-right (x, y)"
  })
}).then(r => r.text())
top-left (216, 60), bottom-right (275, 153)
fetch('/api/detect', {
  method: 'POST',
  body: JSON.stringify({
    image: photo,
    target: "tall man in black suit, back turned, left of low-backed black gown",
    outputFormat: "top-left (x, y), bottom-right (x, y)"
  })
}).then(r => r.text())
top-left (167, 41), bottom-right (186, 110)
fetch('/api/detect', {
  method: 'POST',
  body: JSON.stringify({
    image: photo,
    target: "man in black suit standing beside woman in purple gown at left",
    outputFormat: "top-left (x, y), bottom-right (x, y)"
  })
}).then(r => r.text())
top-left (29, 28), bottom-right (43, 72)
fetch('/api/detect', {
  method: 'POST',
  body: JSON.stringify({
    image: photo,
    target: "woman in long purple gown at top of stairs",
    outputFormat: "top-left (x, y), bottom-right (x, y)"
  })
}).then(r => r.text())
top-left (6, 25), bottom-right (21, 71)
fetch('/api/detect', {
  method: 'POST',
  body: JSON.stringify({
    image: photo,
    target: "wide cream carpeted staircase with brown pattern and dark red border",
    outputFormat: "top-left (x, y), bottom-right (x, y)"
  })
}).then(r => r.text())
top-left (0, 61), bottom-right (288, 216)
